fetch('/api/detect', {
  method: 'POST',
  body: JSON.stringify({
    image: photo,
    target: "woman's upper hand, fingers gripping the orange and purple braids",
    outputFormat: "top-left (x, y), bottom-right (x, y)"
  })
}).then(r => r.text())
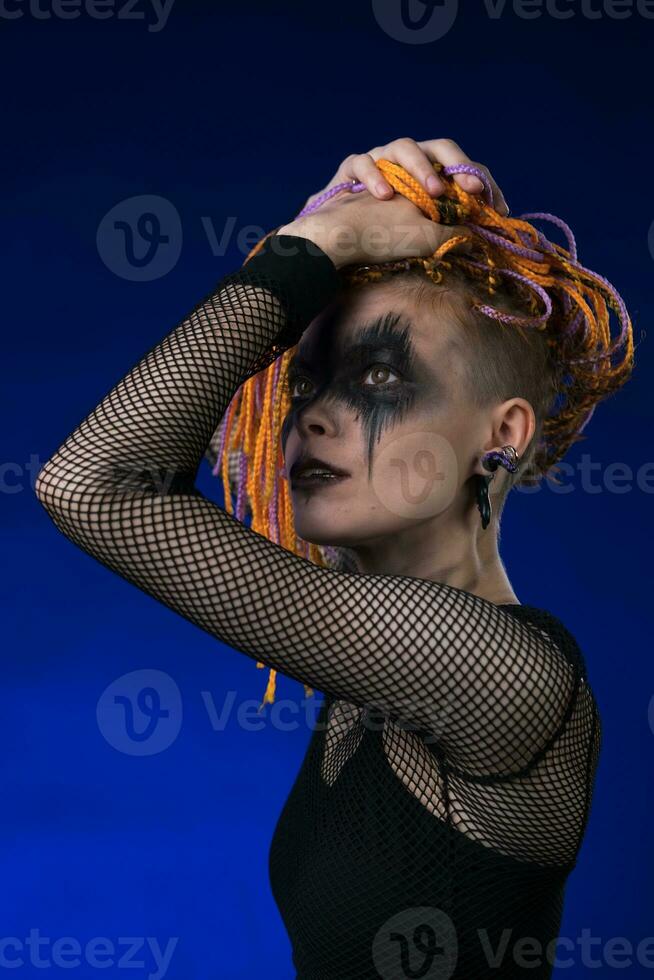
top-left (300, 136), bottom-right (509, 217)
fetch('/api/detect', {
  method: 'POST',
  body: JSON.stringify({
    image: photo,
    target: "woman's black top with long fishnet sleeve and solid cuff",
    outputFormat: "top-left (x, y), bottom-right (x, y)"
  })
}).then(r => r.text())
top-left (36, 236), bottom-right (601, 980)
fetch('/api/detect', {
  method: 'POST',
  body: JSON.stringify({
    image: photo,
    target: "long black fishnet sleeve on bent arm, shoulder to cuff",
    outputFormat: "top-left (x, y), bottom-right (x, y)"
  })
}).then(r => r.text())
top-left (36, 236), bottom-right (579, 774)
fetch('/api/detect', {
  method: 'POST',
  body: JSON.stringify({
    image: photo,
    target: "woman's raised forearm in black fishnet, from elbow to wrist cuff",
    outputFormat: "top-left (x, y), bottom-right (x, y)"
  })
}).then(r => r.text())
top-left (36, 236), bottom-right (339, 511)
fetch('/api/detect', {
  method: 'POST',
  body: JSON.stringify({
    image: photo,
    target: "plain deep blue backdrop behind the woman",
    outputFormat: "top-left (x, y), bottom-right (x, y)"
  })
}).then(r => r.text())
top-left (0, 0), bottom-right (654, 980)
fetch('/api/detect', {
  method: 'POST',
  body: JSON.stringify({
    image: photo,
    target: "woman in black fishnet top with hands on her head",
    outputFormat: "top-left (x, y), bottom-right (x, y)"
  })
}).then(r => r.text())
top-left (36, 139), bottom-right (633, 980)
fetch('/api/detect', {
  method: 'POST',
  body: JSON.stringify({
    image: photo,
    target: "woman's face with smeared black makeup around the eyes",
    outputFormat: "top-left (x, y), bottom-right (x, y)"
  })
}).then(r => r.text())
top-left (282, 283), bottom-right (488, 547)
